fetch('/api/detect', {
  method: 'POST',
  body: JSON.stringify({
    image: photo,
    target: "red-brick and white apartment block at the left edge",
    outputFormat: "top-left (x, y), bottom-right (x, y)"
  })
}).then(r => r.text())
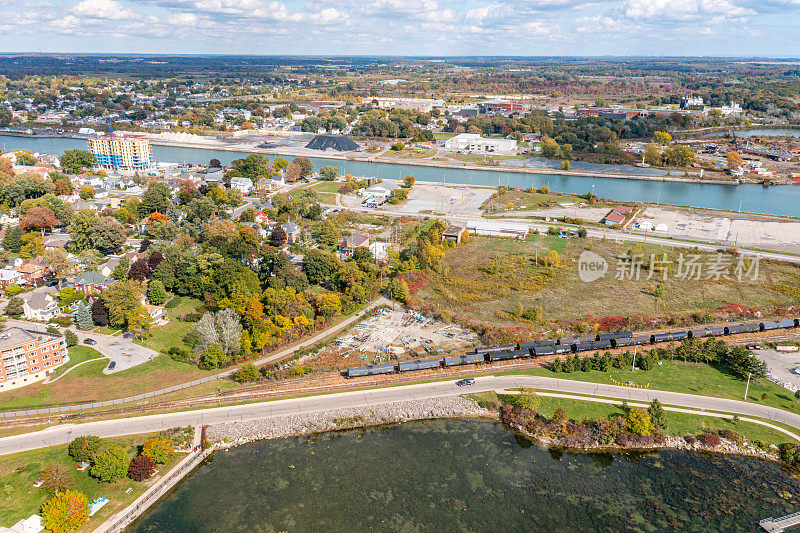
top-left (0, 327), bottom-right (69, 390)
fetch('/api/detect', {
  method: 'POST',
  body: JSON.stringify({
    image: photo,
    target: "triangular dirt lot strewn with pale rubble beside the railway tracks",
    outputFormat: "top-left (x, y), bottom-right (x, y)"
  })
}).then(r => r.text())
top-left (303, 306), bottom-right (478, 368)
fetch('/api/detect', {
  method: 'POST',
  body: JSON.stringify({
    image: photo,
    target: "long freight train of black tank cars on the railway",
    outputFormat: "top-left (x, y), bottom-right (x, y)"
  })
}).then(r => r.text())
top-left (343, 318), bottom-right (800, 378)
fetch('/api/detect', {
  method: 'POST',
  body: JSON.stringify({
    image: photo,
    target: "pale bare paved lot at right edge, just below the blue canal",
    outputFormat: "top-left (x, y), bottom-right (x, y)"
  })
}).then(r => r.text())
top-left (629, 206), bottom-right (800, 253)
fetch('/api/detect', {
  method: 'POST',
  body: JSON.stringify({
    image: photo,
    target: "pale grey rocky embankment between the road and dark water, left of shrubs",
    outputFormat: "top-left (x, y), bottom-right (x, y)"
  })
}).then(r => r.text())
top-left (206, 396), bottom-right (497, 449)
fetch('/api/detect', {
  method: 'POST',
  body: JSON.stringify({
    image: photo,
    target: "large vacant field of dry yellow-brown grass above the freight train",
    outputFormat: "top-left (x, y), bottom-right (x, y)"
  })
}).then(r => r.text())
top-left (416, 235), bottom-right (800, 329)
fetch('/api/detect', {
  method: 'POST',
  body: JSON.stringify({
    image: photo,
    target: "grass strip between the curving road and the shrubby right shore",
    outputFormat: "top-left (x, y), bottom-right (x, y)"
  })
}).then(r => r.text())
top-left (476, 393), bottom-right (794, 444)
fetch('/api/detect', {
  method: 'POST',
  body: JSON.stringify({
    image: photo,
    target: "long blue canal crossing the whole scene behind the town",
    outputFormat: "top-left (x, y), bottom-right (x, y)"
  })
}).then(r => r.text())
top-left (0, 136), bottom-right (800, 216)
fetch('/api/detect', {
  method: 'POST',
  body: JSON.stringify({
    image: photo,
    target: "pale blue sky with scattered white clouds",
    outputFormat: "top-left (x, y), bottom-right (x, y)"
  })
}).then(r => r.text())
top-left (0, 0), bottom-right (800, 57)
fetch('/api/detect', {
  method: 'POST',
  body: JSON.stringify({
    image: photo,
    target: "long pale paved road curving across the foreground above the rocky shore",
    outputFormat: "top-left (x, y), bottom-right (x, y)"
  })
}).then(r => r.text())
top-left (0, 376), bottom-right (800, 455)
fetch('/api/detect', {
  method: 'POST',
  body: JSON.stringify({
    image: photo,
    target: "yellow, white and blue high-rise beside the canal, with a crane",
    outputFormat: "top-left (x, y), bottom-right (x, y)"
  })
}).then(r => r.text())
top-left (88, 132), bottom-right (153, 172)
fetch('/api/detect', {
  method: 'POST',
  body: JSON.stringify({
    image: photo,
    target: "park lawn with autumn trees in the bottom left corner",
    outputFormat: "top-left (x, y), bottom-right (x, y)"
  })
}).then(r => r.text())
top-left (0, 435), bottom-right (185, 532)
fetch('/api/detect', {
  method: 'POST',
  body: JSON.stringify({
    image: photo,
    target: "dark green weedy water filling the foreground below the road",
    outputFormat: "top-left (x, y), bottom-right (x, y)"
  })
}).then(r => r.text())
top-left (130, 420), bottom-right (800, 533)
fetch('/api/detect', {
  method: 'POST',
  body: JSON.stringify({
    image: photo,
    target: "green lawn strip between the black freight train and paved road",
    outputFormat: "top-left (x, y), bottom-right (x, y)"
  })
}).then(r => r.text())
top-left (500, 361), bottom-right (800, 412)
